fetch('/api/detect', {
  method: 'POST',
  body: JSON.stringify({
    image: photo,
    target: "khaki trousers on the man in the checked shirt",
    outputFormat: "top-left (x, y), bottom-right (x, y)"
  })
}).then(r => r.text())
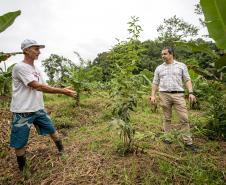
top-left (160, 92), bottom-right (192, 144)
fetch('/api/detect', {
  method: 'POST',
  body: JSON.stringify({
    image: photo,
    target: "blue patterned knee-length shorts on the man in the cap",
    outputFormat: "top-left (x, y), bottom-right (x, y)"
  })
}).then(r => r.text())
top-left (10, 110), bottom-right (56, 149)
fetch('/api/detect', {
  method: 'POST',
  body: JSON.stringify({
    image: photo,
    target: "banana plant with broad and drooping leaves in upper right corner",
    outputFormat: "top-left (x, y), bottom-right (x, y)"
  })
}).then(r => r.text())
top-left (176, 0), bottom-right (226, 80)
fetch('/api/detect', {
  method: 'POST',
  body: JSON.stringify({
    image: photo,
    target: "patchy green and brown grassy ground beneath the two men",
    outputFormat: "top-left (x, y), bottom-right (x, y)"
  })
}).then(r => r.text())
top-left (0, 92), bottom-right (226, 185)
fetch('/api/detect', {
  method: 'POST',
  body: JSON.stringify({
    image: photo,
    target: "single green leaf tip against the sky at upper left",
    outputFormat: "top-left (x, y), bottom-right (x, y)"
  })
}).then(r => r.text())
top-left (0, 10), bottom-right (21, 33)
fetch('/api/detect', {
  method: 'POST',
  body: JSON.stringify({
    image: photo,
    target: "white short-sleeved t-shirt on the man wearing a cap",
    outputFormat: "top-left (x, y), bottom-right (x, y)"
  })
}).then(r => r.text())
top-left (10, 62), bottom-right (45, 113)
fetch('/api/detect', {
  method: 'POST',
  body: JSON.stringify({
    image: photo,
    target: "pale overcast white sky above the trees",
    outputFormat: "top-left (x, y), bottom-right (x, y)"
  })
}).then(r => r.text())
top-left (0, 0), bottom-right (203, 66)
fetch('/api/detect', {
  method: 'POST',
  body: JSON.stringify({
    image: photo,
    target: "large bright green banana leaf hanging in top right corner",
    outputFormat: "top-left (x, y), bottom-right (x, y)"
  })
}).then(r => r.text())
top-left (200, 0), bottom-right (226, 49)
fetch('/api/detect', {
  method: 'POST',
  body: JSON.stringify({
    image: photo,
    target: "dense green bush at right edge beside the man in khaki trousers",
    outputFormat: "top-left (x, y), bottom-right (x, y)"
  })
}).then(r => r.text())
top-left (193, 80), bottom-right (226, 139)
